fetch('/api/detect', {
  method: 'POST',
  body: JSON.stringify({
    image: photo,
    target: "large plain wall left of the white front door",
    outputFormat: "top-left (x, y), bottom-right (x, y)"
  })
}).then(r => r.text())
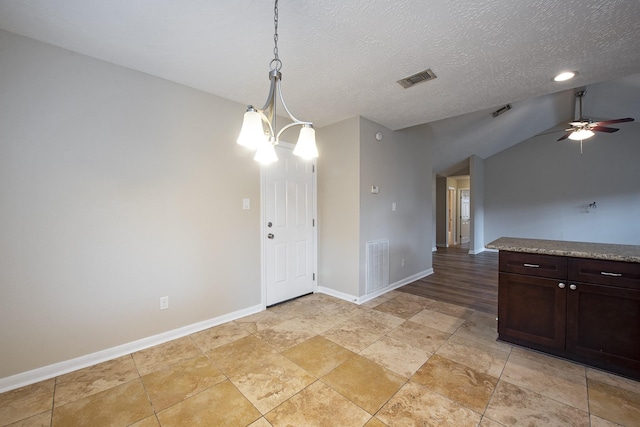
top-left (0, 32), bottom-right (261, 378)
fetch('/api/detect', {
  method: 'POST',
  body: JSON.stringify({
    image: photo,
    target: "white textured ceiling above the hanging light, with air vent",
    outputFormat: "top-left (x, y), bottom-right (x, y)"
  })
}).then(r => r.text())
top-left (0, 0), bottom-right (640, 130)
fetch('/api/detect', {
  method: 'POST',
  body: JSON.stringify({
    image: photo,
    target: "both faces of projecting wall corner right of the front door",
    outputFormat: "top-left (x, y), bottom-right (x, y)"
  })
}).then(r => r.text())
top-left (318, 117), bottom-right (433, 299)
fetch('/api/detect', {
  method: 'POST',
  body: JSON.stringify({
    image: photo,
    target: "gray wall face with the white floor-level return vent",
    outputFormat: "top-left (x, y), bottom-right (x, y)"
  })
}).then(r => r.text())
top-left (359, 118), bottom-right (433, 295)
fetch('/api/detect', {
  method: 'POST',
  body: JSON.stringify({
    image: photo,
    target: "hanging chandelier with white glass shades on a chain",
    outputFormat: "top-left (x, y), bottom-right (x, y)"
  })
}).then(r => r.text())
top-left (237, 0), bottom-right (318, 164)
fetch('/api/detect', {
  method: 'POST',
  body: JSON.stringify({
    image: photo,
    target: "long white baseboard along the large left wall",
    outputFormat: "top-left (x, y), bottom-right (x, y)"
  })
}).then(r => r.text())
top-left (0, 305), bottom-right (264, 393)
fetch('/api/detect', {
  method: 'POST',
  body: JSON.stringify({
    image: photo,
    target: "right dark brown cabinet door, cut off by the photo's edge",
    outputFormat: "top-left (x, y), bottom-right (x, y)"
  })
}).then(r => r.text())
top-left (567, 282), bottom-right (640, 373)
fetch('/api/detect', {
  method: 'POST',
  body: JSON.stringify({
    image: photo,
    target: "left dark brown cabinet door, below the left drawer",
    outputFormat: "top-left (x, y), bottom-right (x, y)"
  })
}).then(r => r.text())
top-left (498, 273), bottom-right (567, 349)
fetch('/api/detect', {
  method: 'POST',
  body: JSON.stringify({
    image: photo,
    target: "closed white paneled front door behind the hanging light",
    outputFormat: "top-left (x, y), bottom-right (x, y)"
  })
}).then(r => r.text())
top-left (262, 144), bottom-right (316, 306)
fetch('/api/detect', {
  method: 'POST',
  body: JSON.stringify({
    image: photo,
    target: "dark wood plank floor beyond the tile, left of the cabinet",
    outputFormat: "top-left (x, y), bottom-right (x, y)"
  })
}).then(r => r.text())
top-left (397, 245), bottom-right (498, 314)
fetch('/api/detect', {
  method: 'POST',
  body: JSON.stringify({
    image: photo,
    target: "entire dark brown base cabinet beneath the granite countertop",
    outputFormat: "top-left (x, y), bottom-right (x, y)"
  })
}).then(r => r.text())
top-left (498, 250), bottom-right (640, 379)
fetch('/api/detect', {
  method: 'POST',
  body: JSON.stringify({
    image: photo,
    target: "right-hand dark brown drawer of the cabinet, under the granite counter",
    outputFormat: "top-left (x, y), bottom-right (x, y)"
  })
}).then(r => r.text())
top-left (569, 258), bottom-right (640, 289)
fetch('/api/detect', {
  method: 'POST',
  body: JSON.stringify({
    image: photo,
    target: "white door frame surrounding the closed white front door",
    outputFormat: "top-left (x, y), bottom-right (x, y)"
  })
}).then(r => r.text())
top-left (260, 141), bottom-right (318, 310)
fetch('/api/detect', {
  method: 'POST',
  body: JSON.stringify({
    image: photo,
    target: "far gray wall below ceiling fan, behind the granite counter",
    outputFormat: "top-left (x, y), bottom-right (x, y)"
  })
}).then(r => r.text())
top-left (484, 122), bottom-right (640, 245)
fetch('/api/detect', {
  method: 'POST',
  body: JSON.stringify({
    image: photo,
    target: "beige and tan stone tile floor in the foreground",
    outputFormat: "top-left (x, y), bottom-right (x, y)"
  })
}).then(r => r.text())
top-left (0, 291), bottom-right (640, 427)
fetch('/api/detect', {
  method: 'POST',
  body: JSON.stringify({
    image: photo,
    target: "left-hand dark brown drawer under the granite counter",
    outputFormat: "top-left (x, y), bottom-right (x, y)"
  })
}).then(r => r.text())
top-left (499, 251), bottom-right (567, 280)
